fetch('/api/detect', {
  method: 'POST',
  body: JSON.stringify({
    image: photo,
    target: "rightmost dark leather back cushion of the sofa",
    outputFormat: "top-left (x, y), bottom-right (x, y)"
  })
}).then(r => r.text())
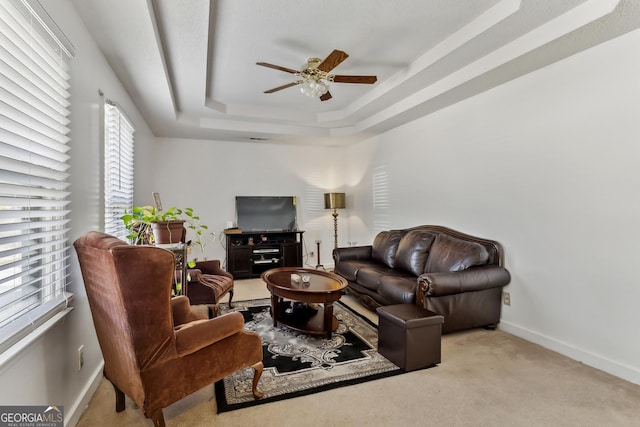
top-left (424, 234), bottom-right (489, 273)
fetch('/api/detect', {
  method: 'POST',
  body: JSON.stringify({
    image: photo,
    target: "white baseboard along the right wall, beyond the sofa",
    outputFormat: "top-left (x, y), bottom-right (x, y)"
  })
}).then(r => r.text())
top-left (498, 320), bottom-right (640, 385)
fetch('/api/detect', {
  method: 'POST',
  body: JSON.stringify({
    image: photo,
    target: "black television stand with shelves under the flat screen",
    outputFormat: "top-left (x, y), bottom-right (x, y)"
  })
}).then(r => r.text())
top-left (225, 231), bottom-right (304, 279)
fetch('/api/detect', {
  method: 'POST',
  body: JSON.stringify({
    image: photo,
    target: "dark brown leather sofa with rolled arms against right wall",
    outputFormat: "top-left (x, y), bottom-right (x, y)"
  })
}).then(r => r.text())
top-left (333, 225), bottom-right (511, 333)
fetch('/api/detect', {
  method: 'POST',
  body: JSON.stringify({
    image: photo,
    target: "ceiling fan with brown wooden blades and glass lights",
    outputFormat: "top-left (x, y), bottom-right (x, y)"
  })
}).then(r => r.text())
top-left (256, 49), bottom-right (377, 101)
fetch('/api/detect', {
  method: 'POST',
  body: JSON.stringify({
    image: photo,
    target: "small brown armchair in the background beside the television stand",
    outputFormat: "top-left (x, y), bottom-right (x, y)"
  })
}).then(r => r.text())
top-left (186, 259), bottom-right (233, 317)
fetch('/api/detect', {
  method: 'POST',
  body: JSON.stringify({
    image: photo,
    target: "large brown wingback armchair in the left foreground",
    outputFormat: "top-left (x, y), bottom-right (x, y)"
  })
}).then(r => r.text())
top-left (74, 231), bottom-right (263, 426)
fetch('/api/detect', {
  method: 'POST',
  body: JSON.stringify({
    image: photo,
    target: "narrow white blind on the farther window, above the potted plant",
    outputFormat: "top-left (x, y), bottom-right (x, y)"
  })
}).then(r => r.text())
top-left (104, 101), bottom-right (135, 240)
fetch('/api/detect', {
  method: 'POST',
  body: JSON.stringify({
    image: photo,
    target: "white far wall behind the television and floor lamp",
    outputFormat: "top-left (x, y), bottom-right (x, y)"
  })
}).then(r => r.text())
top-left (149, 138), bottom-right (347, 266)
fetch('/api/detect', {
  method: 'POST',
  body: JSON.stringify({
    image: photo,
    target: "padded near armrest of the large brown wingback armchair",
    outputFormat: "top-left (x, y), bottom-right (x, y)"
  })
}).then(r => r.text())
top-left (175, 312), bottom-right (244, 356)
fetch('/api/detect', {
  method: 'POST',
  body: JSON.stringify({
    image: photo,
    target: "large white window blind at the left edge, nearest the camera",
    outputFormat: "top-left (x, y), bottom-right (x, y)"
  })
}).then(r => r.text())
top-left (0, 0), bottom-right (72, 352)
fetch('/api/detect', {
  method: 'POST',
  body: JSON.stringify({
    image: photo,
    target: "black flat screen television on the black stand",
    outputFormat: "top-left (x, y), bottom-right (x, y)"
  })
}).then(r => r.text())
top-left (236, 196), bottom-right (298, 231)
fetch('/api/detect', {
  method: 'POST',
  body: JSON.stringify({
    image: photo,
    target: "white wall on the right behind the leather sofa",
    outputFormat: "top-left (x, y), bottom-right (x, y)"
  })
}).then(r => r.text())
top-left (346, 31), bottom-right (640, 384)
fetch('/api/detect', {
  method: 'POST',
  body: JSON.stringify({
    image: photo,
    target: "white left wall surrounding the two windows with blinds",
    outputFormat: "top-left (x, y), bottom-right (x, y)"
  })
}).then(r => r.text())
top-left (0, 0), bottom-right (154, 425)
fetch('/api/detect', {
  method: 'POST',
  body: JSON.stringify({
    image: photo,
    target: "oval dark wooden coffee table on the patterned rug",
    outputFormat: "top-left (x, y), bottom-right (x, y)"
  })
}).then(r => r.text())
top-left (260, 267), bottom-right (347, 338)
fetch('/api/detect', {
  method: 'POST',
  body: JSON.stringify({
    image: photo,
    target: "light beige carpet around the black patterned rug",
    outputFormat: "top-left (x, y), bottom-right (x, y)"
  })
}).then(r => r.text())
top-left (77, 280), bottom-right (640, 427)
